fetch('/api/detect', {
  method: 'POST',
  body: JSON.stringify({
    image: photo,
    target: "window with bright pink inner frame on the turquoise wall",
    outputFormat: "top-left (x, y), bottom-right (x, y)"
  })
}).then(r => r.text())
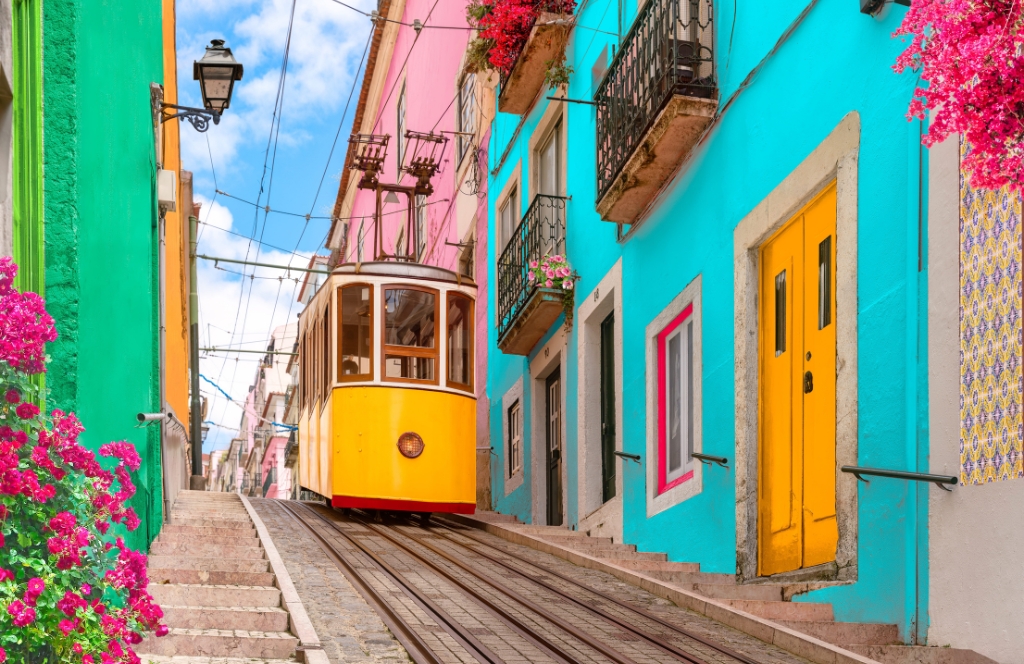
top-left (657, 304), bottom-right (694, 493)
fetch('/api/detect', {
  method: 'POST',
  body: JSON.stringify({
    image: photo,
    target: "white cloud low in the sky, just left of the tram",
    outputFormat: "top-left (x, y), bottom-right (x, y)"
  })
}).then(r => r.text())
top-left (197, 196), bottom-right (309, 449)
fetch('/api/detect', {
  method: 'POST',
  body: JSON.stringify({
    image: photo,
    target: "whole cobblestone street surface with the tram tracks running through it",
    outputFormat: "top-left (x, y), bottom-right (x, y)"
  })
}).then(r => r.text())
top-left (252, 499), bottom-right (806, 664)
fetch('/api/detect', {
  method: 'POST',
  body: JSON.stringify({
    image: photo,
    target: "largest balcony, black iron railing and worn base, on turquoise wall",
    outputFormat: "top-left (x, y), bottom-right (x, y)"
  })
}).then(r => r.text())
top-left (594, 0), bottom-right (718, 223)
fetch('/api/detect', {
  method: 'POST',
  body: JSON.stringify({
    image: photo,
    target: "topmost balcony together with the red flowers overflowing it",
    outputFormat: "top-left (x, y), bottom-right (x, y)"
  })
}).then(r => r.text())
top-left (466, 0), bottom-right (575, 114)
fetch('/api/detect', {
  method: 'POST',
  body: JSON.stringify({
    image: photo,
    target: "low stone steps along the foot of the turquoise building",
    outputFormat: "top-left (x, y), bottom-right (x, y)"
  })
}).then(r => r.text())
top-left (477, 512), bottom-right (997, 664)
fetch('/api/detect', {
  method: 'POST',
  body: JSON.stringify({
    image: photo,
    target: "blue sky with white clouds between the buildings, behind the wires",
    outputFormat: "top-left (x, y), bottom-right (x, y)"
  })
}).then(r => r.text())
top-left (177, 0), bottom-right (376, 451)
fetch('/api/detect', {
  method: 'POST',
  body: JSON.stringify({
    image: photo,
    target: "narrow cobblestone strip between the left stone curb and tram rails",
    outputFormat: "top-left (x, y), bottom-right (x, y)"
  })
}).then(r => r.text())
top-left (252, 498), bottom-right (409, 664)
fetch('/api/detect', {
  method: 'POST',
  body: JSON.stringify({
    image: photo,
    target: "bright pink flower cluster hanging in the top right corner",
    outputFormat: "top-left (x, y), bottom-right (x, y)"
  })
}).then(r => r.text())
top-left (894, 0), bottom-right (1024, 191)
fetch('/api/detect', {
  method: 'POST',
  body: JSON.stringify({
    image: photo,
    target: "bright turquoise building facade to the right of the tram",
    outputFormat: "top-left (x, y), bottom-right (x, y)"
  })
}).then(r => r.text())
top-left (487, 0), bottom-right (938, 644)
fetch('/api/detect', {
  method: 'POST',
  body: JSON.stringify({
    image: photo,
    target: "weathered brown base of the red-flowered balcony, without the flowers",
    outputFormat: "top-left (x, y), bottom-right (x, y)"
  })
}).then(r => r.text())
top-left (498, 0), bottom-right (572, 115)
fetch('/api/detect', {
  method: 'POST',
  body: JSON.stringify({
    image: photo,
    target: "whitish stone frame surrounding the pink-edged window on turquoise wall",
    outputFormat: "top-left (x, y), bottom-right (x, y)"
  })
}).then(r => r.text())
top-left (645, 276), bottom-right (703, 517)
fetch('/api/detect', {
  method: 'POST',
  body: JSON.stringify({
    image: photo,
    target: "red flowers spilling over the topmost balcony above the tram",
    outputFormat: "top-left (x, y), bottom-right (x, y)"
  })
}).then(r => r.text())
top-left (477, 0), bottom-right (575, 74)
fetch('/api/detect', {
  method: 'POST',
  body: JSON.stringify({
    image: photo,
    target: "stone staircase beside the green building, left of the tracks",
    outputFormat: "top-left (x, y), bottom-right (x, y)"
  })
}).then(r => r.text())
top-left (136, 491), bottom-right (299, 664)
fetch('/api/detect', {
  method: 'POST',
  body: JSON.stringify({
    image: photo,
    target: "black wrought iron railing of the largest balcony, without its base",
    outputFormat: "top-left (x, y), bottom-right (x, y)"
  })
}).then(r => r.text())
top-left (594, 0), bottom-right (716, 200)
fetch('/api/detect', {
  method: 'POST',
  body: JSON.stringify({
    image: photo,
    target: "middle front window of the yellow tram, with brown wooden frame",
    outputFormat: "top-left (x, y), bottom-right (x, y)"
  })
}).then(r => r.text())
top-left (384, 288), bottom-right (437, 382)
